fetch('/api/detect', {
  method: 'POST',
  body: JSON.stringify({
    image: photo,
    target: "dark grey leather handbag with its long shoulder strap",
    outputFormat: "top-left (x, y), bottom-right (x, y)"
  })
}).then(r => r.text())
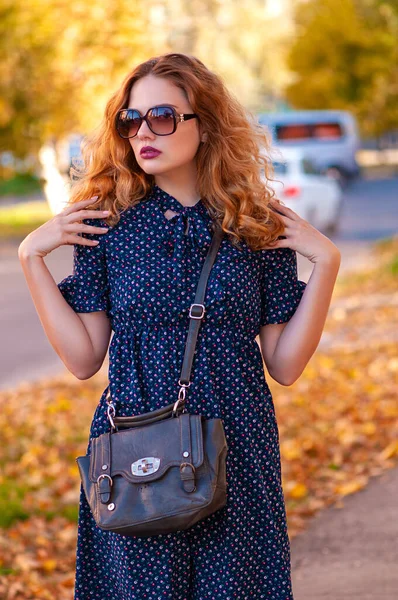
top-left (76, 225), bottom-right (228, 537)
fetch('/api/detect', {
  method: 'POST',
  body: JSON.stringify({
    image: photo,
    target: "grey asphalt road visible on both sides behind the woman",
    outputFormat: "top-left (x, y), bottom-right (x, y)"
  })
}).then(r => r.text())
top-left (0, 178), bottom-right (398, 389)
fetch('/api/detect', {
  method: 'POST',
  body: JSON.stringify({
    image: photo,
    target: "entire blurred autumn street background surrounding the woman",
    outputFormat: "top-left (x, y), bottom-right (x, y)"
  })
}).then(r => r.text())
top-left (0, 0), bottom-right (398, 600)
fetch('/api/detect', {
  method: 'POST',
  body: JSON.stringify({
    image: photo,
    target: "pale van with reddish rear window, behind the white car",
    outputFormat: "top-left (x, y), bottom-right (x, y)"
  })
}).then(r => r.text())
top-left (258, 110), bottom-right (360, 183)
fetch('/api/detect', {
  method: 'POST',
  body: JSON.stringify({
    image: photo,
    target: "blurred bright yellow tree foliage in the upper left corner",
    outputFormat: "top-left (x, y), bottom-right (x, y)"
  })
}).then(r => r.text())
top-left (0, 0), bottom-right (150, 158)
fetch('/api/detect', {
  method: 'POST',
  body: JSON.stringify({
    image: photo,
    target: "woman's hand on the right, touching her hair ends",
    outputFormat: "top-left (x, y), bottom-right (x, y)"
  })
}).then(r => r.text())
top-left (271, 198), bottom-right (341, 263)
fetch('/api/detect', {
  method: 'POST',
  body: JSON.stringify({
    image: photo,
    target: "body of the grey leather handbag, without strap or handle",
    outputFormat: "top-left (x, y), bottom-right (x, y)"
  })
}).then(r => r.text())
top-left (76, 413), bottom-right (228, 537)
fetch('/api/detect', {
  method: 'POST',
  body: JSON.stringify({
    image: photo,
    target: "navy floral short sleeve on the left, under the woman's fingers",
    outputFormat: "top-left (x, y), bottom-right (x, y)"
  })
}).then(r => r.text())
top-left (57, 219), bottom-right (110, 316)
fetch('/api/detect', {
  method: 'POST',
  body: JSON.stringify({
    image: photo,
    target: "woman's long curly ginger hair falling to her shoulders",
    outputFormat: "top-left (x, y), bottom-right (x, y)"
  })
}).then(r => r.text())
top-left (69, 53), bottom-right (284, 250)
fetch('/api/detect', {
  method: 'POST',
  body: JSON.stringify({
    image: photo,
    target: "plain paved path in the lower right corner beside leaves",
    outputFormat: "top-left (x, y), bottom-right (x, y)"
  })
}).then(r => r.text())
top-left (291, 467), bottom-right (398, 600)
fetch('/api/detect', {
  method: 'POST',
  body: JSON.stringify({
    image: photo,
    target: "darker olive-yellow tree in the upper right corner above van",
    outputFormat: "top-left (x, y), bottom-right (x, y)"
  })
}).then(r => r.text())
top-left (285, 0), bottom-right (398, 135)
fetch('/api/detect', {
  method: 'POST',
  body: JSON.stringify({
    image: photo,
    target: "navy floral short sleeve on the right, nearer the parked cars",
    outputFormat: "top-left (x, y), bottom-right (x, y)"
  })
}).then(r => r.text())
top-left (260, 248), bottom-right (307, 326)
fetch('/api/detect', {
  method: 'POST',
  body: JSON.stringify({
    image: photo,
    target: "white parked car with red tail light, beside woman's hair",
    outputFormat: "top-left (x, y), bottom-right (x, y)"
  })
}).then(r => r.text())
top-left (262, 148), bottom-right (343, 235)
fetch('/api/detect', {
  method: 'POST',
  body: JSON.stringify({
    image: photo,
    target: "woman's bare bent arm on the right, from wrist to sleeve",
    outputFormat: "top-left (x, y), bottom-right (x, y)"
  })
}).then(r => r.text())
top-left (260, 251), bottom-right (341, 385)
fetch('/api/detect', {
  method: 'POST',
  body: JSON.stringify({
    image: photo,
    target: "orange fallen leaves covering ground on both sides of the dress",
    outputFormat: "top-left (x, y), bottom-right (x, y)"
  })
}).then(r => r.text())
top-left (0, 237), bottom-right (398, 600)
